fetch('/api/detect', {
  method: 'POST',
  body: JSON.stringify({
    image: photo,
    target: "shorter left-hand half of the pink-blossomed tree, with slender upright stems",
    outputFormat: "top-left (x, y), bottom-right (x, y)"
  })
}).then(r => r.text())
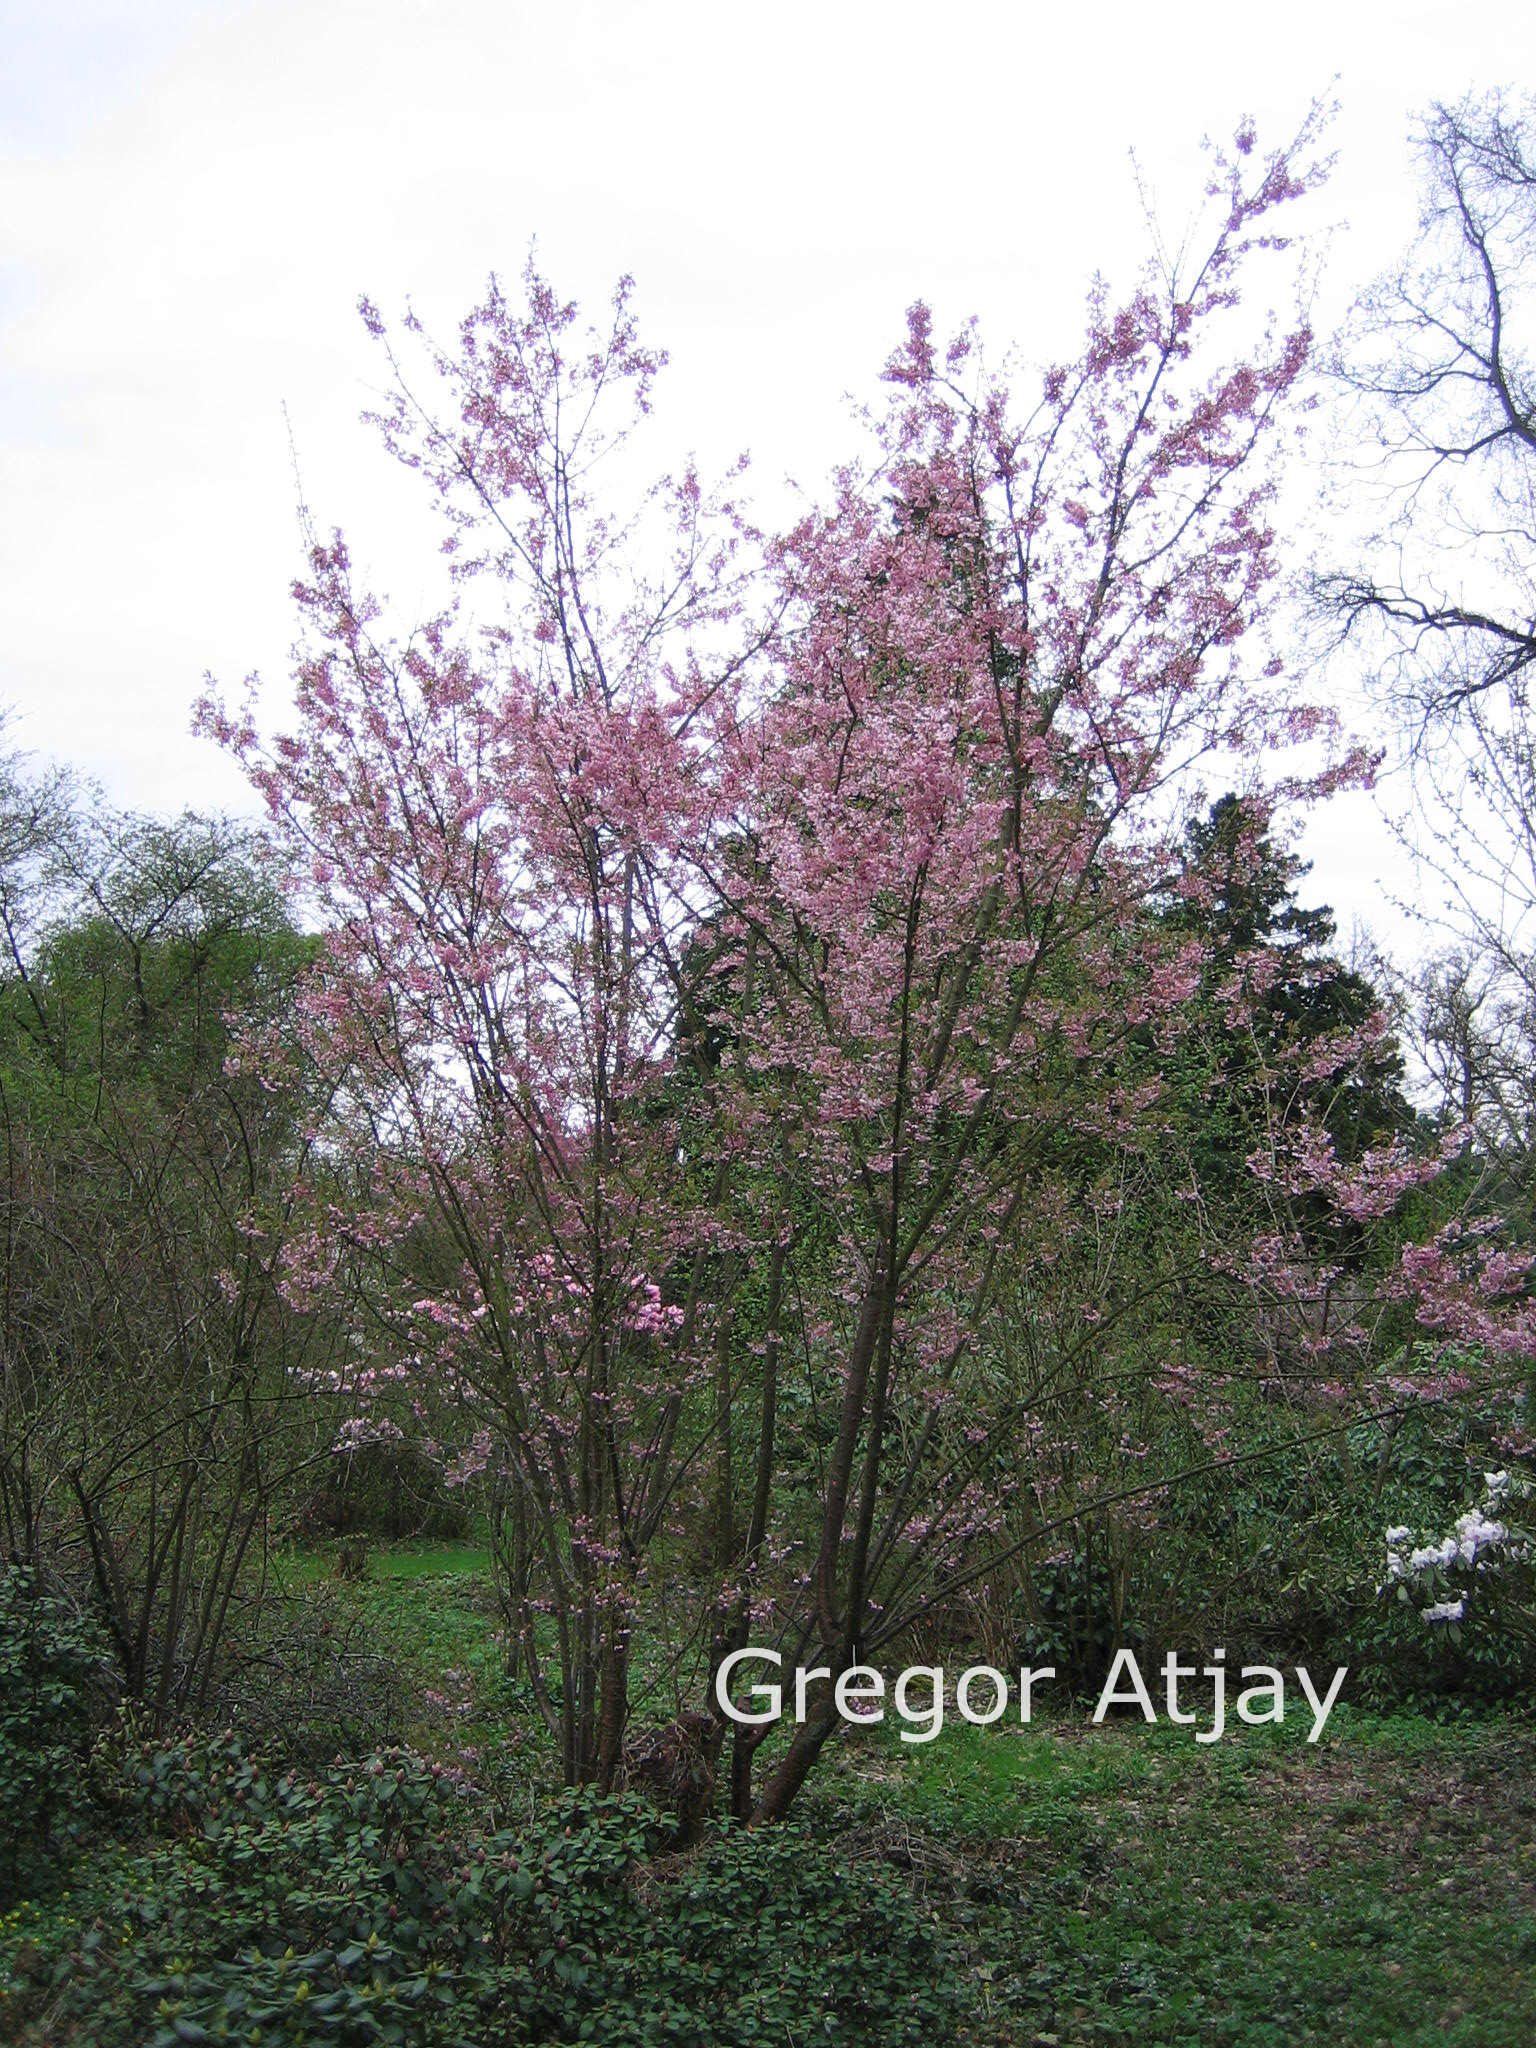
top-left (203, 270), bottom-right (748, 1782)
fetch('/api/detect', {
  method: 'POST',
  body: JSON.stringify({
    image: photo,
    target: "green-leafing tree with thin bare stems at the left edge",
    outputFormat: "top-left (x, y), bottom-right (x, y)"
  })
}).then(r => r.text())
top-left (0, 790), bottom-right (326, 1720)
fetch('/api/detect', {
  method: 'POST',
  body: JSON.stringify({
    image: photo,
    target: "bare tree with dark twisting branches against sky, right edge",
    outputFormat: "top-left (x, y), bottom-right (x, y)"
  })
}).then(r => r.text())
top-left (1313, 94), bottom-right (1536, 1159)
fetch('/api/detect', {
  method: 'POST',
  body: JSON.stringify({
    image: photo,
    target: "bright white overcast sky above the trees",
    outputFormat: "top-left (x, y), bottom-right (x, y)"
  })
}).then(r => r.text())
top-left (0, 0), bottom-right (1536, 950)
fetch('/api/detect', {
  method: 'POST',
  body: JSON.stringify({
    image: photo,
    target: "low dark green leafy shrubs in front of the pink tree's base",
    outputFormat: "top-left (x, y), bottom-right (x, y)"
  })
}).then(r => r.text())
top-left (41, 1737), bottom-right (954, 2048)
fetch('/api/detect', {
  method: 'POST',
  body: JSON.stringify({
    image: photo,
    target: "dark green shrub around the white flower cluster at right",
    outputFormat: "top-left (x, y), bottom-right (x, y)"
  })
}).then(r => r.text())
top-left (991, 1401), bottom-right (1536, 1714)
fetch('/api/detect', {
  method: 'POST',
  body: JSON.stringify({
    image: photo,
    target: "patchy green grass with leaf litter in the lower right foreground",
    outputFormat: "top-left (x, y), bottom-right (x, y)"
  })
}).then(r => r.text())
top-left (817, 1710), bottom-right (1536, 2048)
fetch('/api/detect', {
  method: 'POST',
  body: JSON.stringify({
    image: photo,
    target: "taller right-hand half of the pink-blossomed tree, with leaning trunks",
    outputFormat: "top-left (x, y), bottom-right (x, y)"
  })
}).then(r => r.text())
top-left (709, 116), bottom-right (1364, 1815)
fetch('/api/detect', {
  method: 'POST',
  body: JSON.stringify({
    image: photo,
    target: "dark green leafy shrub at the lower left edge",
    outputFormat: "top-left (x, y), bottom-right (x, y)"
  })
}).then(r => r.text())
top-left (0, 1565), bottom-right (106, 1905)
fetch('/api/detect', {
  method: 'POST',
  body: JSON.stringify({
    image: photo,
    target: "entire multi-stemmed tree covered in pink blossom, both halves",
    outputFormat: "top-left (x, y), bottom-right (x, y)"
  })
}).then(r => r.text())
top-left (203, 112), bottom-right (1518, 1817)
